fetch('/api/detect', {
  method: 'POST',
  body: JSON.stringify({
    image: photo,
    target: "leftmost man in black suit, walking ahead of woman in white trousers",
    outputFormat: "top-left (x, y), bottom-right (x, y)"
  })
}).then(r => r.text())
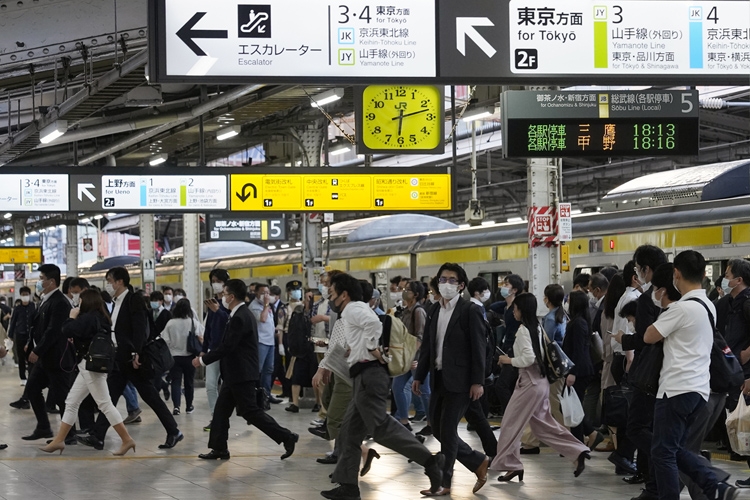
top-left (22, 264), bottom-right (75, 441)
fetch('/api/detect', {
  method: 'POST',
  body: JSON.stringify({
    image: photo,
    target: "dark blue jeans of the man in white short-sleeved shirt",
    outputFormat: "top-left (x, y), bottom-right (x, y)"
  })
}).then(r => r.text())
top-left (651, 392), bottom-right (718, 500)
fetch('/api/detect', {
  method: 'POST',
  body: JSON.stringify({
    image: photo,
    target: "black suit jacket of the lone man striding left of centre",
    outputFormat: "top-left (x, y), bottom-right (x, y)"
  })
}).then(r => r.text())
top-left (202, 304), bottom-right (260, 384)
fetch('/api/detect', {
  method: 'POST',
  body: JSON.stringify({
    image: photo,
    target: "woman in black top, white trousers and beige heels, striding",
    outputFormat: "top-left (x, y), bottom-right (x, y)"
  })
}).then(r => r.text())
top-left (40, 289), bottom-right (135, 456)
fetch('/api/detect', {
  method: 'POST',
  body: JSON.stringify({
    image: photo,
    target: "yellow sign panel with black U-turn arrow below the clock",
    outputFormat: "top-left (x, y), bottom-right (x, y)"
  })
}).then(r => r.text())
top-left (230, 173), bottom-right (451, 212)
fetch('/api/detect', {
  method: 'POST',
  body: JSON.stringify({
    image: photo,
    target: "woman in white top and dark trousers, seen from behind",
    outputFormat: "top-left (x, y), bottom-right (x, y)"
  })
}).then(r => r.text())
top-left (161, 299), bottom-right (203, 415)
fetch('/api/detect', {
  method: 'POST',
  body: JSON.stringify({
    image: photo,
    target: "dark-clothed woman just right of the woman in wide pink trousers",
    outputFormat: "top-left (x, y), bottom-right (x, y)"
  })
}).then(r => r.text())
top-left (564, 291), bottom-right (603, 449)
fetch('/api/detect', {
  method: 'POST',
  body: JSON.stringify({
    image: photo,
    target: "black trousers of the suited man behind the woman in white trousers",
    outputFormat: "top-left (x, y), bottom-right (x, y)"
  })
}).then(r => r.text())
top-left (91, 363), bottom-right (179, 441)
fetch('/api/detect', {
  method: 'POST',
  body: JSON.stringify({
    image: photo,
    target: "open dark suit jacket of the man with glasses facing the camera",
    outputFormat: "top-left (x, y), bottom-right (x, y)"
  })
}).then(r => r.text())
top-left (414, 297), bottom-right (487, 393)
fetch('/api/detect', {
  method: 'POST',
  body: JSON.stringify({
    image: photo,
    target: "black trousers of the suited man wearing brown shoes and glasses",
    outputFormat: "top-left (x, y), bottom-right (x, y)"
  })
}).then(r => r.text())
top-left (430, 370), bottom-right (488, 488)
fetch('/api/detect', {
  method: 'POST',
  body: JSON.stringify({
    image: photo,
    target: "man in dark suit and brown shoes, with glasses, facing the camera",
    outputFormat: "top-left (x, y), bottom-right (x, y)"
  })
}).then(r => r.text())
top-left (413, 263), bottom-right (490, 495)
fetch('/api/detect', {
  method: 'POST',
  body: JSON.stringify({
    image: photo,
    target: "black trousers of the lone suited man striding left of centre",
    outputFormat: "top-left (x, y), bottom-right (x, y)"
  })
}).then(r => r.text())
top-left (208, 380), bottom-right (291, 451)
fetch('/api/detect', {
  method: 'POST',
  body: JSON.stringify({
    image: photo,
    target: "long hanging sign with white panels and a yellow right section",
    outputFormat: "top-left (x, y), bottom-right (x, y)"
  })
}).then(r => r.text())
top-left (0, 167), bottom-right (452, 213)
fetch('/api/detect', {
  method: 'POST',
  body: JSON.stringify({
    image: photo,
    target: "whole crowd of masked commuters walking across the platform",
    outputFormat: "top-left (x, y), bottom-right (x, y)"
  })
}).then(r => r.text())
top-left (3, 245), bottom-right (750, 500)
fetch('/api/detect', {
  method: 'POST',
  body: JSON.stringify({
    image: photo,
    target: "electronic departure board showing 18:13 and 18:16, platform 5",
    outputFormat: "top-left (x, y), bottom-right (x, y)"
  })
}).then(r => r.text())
top-left (502, 90), bottom-right (699, 158)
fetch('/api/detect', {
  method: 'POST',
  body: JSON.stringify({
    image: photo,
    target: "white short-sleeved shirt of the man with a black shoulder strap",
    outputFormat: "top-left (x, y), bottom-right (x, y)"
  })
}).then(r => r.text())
top-left (654, 289), bottom-right (716, 401)
